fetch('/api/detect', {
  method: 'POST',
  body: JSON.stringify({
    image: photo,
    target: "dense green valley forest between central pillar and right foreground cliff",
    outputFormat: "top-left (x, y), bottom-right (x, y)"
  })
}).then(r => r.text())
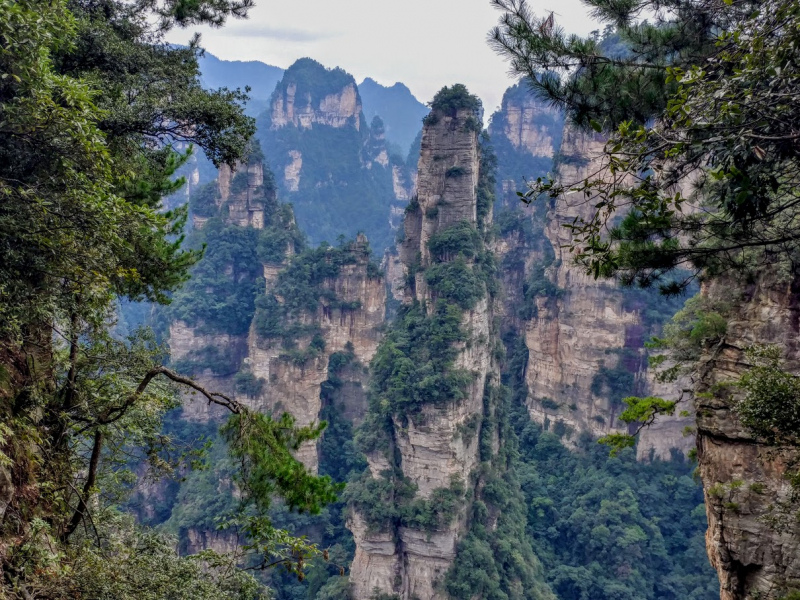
top-left (503, 336), bottom-right (719, 600)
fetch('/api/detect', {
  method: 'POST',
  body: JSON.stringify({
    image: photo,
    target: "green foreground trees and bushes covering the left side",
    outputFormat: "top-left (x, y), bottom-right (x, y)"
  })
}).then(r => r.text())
top-left (0, 0), bottom-right (346, 600)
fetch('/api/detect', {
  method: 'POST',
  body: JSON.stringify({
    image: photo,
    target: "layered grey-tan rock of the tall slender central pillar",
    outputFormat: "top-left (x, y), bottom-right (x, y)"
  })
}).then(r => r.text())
top-left (348, 91), bottom-right (536, 600)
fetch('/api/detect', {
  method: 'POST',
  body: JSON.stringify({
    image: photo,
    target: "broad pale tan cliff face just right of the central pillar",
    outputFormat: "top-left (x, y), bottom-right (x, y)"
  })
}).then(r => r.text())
top-left (525, 126), bottom-right (692, 459)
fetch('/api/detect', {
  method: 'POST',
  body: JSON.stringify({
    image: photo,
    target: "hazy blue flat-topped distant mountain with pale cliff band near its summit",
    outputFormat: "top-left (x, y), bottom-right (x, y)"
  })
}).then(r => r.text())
top-left (256, 58), bottom-right (400, 253)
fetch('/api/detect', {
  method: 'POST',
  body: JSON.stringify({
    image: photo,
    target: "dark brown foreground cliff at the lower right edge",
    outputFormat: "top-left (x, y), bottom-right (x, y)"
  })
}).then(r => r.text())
top-left (695, 274), bottom-right (800, 600)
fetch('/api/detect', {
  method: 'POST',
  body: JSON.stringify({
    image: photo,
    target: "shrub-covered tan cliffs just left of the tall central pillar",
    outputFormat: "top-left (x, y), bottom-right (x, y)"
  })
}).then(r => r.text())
top-left (169, 148), bottom-right (386, 469)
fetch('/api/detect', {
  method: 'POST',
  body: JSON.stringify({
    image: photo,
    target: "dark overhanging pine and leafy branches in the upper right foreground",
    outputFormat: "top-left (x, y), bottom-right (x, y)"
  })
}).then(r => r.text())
top-left (494, 0), bottom-right (800, 294)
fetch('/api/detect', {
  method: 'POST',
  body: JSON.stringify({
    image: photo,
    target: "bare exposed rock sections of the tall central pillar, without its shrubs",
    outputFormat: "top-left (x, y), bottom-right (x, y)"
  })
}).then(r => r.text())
top-left (348, 103), bottom-right (496, 600)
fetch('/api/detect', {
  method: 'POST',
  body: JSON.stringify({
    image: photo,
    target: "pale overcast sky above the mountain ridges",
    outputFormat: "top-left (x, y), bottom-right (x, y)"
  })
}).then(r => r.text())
top-left (170, 0), bottom-right (598, 114)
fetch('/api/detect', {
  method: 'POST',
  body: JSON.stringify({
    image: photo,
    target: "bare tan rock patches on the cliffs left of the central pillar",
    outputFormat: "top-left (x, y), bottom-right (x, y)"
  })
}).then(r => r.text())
top-left (169, 162), bottom-right (386, 470)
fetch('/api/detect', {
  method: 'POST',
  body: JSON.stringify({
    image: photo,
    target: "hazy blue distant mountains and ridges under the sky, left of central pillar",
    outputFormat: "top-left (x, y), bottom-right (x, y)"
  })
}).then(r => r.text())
top-left (169, 53), bottom-right (427, 254)
